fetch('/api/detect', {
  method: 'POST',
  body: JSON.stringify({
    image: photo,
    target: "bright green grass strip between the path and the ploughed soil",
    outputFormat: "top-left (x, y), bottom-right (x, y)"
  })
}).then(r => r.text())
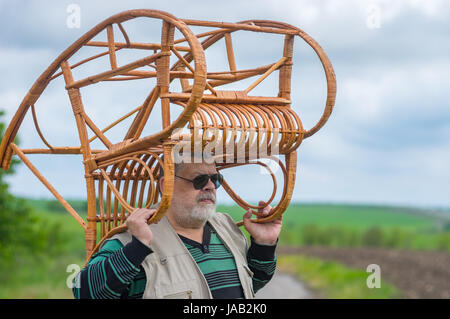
top-left (278, 255), bottom-right (401, 299)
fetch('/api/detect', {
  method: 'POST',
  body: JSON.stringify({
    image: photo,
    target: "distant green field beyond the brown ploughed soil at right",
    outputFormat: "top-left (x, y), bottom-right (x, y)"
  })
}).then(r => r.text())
top-left (218, 204), bottom-right (450, 251)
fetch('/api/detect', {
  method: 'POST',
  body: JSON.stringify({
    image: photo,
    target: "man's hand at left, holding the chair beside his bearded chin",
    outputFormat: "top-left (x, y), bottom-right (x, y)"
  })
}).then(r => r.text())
top-left (125, 208), bottom-right (156, 246)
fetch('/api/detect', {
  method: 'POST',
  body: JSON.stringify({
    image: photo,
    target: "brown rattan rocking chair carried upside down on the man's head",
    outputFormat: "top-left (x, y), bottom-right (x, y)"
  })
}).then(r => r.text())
top-left (0, 9), bottom-right (336, 259)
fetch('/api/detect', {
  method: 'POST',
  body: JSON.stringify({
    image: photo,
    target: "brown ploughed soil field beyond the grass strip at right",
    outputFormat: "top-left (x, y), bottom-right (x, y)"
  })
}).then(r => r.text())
top-left (278, 247), bottom-right (450, 298)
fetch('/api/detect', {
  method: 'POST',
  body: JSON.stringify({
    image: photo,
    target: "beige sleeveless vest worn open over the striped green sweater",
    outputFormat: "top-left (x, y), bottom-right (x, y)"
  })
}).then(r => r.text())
top-left (111, 213), bottom-right (255, 299)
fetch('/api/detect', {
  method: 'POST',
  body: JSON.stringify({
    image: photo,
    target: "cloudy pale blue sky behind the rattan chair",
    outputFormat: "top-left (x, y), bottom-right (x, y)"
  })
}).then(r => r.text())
top-left (0, 0), bottom-right (450, 207)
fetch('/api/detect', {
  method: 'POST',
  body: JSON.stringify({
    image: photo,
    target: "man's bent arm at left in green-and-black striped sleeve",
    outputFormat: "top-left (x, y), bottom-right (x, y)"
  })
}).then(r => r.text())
top-left (73, 236), bottom-right (152, 299)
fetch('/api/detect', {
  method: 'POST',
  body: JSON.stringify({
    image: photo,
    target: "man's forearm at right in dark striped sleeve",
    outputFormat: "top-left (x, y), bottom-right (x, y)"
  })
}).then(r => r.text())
top-left (247, 237), bottom-right (277, 293)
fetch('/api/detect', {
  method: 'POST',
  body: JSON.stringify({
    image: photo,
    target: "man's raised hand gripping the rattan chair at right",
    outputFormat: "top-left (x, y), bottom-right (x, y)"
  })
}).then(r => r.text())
top-left (243, 201), bottom-right (283, 245)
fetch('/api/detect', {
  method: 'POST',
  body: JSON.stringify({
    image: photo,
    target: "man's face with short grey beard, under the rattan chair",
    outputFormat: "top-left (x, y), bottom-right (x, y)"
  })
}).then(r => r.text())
top-left (170, 163), bottom-right (217, 228)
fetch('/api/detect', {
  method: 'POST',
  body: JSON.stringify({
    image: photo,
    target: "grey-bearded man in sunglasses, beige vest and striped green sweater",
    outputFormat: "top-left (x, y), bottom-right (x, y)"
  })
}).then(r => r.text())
top-left (73, 158), bottom-right (281, 299)
